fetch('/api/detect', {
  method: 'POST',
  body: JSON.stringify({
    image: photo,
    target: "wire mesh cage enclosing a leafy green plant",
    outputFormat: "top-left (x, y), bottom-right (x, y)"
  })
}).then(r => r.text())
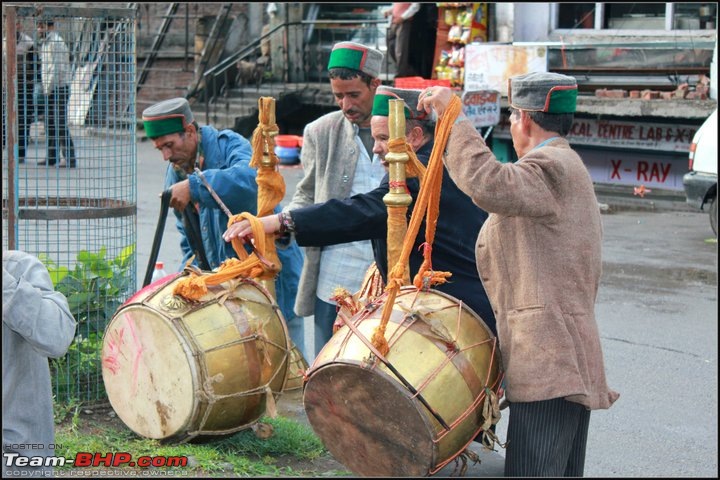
top-left (2, 3), bottom-right (137, 402)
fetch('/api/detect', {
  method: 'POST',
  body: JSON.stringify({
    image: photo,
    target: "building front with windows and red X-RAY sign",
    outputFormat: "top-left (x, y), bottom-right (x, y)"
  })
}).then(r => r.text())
top-left (484, 3), bottom-right (718, 193)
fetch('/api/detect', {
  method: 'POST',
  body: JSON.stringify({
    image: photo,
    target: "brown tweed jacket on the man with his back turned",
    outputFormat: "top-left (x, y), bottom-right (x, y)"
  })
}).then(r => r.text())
top-left (444, 121), bottom-right (619, 409)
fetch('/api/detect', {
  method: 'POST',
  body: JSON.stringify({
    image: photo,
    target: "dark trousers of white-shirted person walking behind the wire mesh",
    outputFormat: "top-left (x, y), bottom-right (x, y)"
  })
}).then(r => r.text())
top-left (45, 87), bottom-right (75, 165)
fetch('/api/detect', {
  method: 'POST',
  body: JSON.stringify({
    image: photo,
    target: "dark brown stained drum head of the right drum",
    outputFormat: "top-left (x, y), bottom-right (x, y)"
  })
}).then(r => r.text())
top-left (303, 363), bottom-right (435, 477)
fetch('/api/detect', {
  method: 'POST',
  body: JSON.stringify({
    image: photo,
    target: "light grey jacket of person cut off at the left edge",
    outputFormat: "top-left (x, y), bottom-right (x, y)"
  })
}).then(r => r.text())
top-left (2, 250), bottom-right (76, 477)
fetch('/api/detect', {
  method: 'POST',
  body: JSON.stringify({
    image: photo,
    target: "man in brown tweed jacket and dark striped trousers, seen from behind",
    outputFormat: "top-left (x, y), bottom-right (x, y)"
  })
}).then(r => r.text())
top-left (418, 73), bottom-right (618, 477)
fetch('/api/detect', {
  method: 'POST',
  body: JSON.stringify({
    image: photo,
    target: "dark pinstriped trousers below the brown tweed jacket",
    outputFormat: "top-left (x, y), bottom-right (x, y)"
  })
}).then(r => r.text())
top-left (505, 398), bottom-right (590, 477)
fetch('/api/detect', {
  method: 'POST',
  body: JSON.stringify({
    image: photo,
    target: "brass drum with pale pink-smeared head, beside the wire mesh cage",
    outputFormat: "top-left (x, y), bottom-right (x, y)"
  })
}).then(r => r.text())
top-left (102, 273), bottom-right (290, 442)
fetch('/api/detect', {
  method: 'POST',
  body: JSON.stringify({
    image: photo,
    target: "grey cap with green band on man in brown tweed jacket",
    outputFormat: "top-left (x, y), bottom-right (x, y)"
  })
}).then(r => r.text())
top-left (508, 72), bottom-right (577, 113)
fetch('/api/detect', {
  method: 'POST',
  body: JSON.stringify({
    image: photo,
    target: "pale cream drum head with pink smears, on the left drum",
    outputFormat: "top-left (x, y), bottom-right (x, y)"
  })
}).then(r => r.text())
top-left (102, 306), bottom-right (197, 439)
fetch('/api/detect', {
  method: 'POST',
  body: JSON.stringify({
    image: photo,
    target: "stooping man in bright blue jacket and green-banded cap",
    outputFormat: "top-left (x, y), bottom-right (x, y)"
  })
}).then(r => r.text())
top-left (142, 98), bottom-right (305, 355)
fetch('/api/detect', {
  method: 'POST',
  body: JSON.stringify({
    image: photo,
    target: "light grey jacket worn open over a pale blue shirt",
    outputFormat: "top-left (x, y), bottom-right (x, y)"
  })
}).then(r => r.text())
top-left (284, 110), bottom-right (368, 316)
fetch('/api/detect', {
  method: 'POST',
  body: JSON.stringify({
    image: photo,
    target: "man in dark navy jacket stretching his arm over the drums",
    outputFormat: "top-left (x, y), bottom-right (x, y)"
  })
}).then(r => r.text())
top-left (224, 86), bottom-right (495, 334)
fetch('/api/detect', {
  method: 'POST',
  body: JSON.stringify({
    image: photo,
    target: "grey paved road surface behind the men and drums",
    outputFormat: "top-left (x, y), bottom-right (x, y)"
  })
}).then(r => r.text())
top-left (138, 142), bottom-right (718, 477)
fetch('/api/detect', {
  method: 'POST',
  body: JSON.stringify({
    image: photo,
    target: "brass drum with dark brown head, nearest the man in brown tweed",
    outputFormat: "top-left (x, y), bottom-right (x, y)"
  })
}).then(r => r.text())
top-left (303, 287), bottom-right (502, 477)
